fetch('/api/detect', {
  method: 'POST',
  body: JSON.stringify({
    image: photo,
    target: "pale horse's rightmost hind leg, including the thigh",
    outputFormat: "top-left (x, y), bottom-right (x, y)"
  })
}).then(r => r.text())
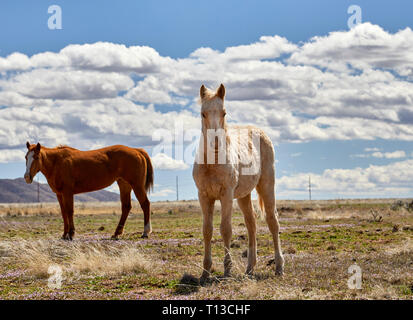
top-left (256, 180), bottom-right (284, 275)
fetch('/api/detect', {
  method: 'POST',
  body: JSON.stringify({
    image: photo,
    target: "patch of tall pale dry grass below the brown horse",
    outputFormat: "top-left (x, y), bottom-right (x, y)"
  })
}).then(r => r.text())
top-left (0, 239), bottom-right (158, 278)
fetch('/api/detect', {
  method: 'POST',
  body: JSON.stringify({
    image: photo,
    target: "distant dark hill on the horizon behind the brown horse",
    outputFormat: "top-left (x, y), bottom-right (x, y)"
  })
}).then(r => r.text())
top-left (0, 178), bottom-right (119, 203)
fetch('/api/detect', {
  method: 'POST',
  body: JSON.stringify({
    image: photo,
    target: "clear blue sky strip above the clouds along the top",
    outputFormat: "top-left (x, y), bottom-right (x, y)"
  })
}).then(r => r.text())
top-left (0, 0), bottom-right (413, 58)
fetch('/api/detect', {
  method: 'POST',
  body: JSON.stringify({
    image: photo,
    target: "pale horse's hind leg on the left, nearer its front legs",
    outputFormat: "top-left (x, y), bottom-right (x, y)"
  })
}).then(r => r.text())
top-left (238, 194), bottom-right (257, 274)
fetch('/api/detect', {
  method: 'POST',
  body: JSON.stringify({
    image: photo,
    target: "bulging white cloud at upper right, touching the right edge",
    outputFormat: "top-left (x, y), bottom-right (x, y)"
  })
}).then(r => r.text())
top-left (289, 22), bottom-right (413, 76)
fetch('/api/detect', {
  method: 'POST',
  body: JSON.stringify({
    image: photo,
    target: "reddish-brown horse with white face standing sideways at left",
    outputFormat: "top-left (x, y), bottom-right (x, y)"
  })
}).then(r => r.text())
top-left (24, 142), bottom-right (153, 240)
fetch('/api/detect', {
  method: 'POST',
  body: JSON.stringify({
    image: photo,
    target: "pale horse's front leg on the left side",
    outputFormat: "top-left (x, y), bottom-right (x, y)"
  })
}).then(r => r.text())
top-left (199, 193), bottom-right (215, 282)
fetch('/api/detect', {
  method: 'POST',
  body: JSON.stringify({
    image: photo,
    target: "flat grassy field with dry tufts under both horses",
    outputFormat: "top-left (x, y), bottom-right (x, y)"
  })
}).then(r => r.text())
top-left (0, 199), bottom-right (413, 299)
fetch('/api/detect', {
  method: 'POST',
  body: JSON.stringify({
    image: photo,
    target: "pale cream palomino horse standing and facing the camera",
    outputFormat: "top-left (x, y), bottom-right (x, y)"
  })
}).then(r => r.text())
top-left (193, 84), bottom-right (284, 280)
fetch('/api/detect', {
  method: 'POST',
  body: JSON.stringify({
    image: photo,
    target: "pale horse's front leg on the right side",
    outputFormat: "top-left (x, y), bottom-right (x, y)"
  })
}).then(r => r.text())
top-left (220, 190), bottom-right (234, 278)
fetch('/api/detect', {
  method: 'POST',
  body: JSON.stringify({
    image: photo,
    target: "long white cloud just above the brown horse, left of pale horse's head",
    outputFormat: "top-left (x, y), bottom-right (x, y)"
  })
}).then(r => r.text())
top-left (0, 97), bottom-right (199, 149)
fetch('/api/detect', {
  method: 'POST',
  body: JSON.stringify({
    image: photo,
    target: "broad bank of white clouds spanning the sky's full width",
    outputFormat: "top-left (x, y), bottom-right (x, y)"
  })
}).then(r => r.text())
top-left (0, 23), bottom-right (413, 162)
